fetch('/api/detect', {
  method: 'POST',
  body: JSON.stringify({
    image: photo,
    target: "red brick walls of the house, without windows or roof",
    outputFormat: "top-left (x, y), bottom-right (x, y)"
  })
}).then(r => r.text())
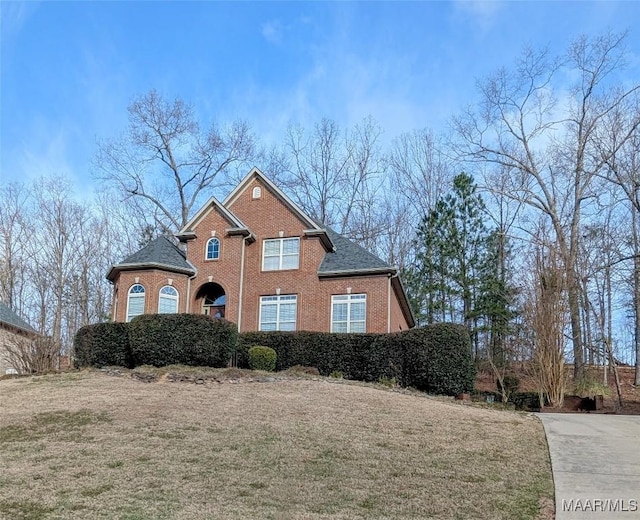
top-left (109, 173), bottom-right (408, 332)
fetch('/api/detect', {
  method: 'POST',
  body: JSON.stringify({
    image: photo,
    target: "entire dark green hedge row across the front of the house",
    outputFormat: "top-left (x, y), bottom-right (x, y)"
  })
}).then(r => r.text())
top-left (74, 314), bottom-right (475, 395)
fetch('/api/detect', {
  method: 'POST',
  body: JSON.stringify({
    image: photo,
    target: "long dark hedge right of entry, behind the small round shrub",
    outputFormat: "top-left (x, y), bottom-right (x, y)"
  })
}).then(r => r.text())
top-left (237, 323), bottom-right (476, 395)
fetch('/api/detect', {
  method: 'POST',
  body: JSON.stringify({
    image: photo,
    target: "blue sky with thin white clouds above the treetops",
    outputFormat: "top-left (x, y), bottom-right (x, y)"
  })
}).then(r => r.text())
top-left (0, 1), bottom-right (640, 192)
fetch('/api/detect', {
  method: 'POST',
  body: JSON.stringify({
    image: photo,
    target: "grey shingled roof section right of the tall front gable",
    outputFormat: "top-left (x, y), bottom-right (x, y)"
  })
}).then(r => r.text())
top-left (318, 228), bottom-right (396, 276)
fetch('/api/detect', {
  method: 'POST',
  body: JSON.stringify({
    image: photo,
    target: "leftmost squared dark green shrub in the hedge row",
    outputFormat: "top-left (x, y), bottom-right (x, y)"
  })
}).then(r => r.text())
top-left (73, 323), bottom-right (133, 368)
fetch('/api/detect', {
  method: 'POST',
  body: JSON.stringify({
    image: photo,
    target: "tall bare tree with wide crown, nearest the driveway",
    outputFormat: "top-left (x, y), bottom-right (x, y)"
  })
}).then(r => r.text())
top-left (454, 33), bottom-right (640, 379)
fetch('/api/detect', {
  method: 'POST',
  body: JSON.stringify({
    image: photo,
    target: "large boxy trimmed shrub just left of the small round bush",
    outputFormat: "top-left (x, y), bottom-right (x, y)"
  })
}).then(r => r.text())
top-left (129, 314), bottom-right (237, 368)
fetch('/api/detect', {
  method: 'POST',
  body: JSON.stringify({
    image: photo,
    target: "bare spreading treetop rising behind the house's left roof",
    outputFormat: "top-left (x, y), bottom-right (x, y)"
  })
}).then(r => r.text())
top-left (96, 90), bottom-right (255, 232)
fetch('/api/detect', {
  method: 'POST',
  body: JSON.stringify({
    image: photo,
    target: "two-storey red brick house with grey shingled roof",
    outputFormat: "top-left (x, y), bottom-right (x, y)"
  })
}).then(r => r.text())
top-left (107, 168), bottom-right (414, 332)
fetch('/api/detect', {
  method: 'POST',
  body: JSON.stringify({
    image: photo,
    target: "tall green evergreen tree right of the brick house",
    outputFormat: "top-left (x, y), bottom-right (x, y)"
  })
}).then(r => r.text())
top-left (404, 173), bottom-right (513, 359)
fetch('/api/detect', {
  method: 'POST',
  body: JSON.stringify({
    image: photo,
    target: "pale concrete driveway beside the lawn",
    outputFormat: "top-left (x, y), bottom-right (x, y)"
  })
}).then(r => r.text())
top-left (538, 413), bottom-right (640, 520)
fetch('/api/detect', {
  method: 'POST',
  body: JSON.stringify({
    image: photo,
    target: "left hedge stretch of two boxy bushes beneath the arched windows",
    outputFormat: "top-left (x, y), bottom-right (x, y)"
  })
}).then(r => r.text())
top-left (74, 314), bottom-right (238, 368)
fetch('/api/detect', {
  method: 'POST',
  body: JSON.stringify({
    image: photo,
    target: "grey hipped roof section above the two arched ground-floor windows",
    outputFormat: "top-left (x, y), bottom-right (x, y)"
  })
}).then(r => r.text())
top-left (107, 236), bottom-right (196, 280)
